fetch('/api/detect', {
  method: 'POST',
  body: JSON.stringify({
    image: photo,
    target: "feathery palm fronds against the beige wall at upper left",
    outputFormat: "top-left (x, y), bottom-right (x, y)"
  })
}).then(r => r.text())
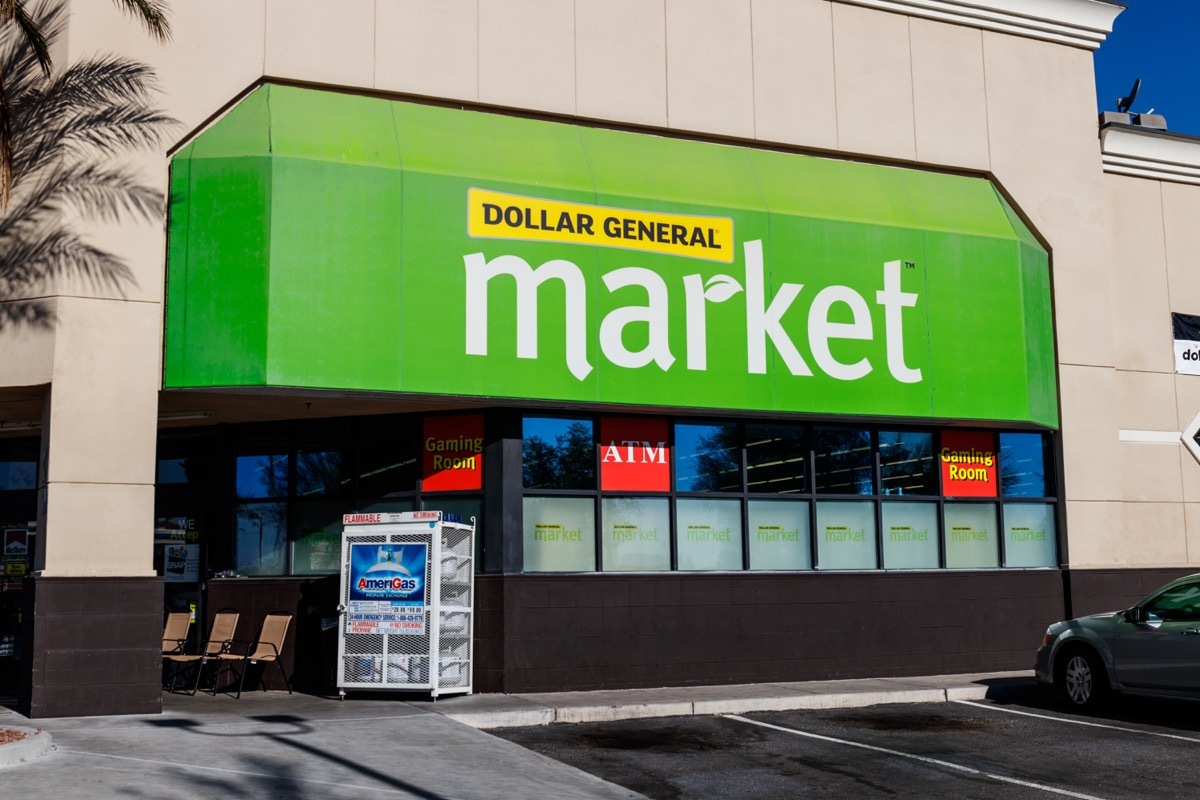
top-left (0, 1), bottom-right (176, 331)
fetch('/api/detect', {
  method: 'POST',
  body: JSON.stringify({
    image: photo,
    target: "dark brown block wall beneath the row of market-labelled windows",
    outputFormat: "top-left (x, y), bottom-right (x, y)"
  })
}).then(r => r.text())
top-left (492, 571), bottom-right (1063, 692)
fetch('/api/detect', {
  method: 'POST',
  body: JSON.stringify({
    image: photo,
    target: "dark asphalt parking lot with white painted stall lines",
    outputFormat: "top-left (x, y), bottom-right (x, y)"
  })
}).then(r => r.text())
top-left (496, 682), bottom-right (1200, 800)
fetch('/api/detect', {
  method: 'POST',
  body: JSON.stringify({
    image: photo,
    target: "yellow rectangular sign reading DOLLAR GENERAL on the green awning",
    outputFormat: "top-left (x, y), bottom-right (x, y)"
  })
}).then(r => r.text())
top-left (467, 188), bottom-right (733, 264)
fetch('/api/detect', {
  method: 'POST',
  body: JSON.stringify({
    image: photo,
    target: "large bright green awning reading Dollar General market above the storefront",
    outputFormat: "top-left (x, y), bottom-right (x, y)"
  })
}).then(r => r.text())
top-left (166, 86), bottom-right (1057, 426)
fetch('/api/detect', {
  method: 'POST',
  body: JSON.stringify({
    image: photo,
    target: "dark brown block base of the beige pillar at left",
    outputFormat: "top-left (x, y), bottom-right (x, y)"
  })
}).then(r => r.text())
top-left (18, 578), bottom-right (163, 718)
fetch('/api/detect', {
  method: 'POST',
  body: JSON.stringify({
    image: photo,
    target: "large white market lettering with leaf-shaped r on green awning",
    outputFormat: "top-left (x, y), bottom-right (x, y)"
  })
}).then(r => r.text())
top-left (463, 240), bottom-right (923, 384)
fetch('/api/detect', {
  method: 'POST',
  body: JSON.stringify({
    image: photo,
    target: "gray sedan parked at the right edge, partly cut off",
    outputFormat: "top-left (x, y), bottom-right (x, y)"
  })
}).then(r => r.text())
top-left (1034, 575), bottom-right (1200, 708)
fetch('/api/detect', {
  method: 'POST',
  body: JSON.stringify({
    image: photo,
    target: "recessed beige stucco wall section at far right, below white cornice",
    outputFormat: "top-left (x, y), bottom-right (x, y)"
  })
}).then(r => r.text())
top-left (1089, 173), bottom-right (1200, 566)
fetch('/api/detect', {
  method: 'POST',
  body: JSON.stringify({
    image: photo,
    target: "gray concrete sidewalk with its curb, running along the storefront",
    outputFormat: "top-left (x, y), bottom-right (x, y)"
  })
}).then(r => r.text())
top-left (0, 673), bottom-right (1033, 800)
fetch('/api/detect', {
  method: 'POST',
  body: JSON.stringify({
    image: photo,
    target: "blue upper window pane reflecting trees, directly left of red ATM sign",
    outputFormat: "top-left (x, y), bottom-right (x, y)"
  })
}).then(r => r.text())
top-left (521, 416), bottom-right (596, 489)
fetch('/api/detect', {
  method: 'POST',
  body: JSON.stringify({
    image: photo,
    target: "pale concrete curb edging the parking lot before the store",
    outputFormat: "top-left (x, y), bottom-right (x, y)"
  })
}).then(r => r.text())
top-left (445, 685), bottom-right (988, 730)
